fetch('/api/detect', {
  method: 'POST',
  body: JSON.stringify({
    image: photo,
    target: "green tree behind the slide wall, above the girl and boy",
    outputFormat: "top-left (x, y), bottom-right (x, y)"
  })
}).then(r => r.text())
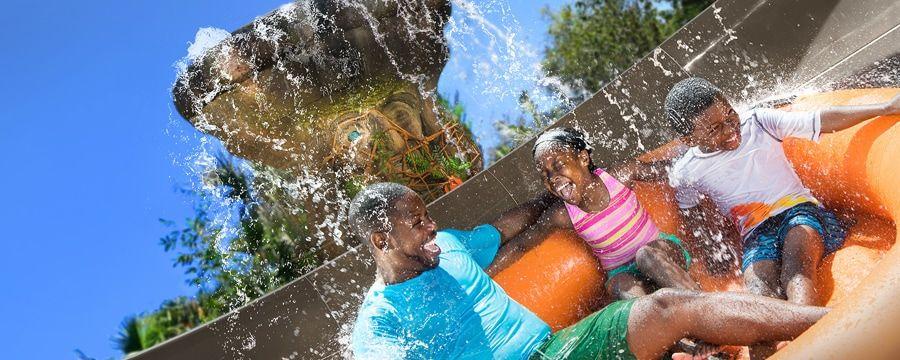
top-left (489, 0), bottom-right (713, 161)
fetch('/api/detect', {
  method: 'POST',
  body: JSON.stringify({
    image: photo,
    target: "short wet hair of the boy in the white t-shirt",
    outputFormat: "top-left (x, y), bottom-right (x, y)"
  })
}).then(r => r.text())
top-left (666, 77), bottom-right (725, 136)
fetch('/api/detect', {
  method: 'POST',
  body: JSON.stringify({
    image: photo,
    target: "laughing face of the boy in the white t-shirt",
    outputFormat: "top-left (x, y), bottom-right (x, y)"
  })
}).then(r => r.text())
top-left (683, 99), bottom-right (741, 152)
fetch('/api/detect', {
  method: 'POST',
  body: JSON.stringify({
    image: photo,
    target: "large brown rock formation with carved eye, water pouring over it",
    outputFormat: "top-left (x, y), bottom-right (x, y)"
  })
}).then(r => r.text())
top-left (173, 0), bottom-right (481, 205)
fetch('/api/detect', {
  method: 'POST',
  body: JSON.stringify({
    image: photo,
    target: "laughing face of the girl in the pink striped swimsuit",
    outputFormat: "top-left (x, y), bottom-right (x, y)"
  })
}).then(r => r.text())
top-left (535, 146), bottom-right (592, 205)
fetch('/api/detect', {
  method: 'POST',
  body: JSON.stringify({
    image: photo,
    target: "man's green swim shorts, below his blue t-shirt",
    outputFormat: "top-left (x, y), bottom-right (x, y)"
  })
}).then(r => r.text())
top-left (531, 299), bottom-right (636, 360)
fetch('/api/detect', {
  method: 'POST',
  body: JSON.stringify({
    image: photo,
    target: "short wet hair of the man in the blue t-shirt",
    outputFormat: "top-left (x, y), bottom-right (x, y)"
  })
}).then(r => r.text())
top-left (347, 182), bottom-right (413, 244)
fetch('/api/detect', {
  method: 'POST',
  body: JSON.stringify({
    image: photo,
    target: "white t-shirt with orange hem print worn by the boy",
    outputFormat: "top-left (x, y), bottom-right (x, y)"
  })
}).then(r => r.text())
top-left (669, 109), bottom-right (822, 236)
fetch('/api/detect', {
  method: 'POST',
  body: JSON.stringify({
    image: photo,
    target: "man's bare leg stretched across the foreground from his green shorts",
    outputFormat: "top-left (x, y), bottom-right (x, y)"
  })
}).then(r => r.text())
top-left (628, 289), bottom-right (828, 359)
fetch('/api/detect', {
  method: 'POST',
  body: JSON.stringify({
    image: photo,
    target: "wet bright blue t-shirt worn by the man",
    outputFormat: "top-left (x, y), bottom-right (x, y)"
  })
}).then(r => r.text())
top-left (351, 225), bottom-right (550, 359)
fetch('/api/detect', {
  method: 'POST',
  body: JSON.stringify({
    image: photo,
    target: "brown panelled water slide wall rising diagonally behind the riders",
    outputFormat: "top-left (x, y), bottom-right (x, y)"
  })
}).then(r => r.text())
top-left (133, 0), bottom-right (900, 360)
